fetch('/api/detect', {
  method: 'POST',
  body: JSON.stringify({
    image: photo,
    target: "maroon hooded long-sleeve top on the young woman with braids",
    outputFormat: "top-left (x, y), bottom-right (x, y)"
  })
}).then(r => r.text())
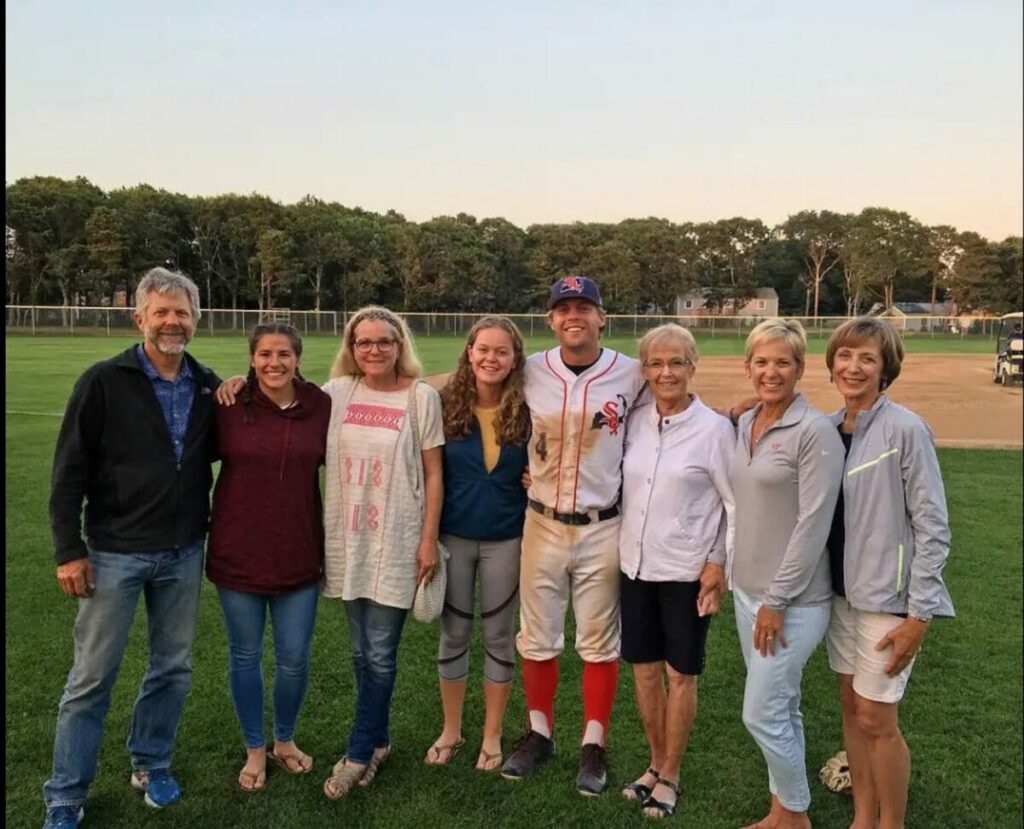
top-left (206, 381), bottom-right (331, 595)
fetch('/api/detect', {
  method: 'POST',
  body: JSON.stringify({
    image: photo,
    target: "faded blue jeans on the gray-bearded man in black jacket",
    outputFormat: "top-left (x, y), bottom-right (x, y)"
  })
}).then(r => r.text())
top-left (43, 540), bottom-right (203, 809)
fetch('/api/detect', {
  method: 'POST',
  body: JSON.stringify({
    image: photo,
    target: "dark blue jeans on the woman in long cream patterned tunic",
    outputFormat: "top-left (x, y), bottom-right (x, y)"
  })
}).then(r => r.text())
top-left (345, 599), bottom-right (409, 763)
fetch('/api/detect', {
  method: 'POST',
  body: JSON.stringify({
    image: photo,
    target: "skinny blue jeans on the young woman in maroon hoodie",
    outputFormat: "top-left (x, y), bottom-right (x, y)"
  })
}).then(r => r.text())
top-left (217, 584), bottom-right (319, 748)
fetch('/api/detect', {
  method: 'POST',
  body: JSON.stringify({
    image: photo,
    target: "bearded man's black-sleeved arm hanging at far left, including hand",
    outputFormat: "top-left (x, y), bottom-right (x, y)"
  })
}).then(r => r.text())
top-left (50, 369), bottom-right (105, 598)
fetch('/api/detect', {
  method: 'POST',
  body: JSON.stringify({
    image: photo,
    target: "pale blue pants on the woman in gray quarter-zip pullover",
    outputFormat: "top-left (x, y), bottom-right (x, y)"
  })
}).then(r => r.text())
top-left (733, 590), bottom-right (831, 812)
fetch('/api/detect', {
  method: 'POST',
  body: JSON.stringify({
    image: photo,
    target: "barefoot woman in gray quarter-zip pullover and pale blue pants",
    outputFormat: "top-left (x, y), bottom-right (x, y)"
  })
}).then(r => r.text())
top-left (730, 318), bottom-right (843, 829)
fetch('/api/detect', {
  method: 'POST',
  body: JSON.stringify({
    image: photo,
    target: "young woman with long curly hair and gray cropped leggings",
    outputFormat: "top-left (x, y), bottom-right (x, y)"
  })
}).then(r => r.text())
top-left (424, 316), bottom-right (530, 772)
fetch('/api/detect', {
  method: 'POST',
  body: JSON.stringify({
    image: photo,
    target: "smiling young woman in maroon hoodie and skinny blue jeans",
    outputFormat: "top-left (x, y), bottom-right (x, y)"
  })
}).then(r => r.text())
top-left (206, 322), bottom-right (331, 791)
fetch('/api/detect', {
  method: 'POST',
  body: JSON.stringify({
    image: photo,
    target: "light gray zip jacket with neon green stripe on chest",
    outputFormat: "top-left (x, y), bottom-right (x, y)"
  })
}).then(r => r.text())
top-left (829, 394), bottom-right (954, 620)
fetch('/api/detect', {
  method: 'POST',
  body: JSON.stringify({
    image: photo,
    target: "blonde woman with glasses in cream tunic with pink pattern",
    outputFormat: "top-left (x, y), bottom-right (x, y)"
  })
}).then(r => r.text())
top-left (324, 306), bottom-right (444, 800)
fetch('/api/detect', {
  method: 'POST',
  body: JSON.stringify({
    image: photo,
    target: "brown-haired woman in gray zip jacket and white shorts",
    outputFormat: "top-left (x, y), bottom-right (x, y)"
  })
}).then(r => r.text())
top-left (825, 317), bottom-right (953, 829)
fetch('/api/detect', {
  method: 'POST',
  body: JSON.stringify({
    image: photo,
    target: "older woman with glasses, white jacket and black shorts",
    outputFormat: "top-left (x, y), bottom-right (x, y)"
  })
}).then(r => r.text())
top-left (620, 324), bottom-right (736, 818)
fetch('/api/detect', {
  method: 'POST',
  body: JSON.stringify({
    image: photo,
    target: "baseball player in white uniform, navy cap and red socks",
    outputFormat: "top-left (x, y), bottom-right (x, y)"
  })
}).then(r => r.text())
top-left (502, 276), bottom-right (643, 795)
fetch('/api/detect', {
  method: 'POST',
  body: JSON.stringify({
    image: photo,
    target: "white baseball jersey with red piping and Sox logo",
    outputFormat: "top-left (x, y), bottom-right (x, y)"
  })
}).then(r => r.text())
top-left (524, 348), bottom-right (643, 513)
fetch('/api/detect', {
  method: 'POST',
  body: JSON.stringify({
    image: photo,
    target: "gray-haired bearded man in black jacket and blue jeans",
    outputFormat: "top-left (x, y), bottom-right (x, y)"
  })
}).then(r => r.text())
top-left (43, 268), bottom-right (220, 829)
